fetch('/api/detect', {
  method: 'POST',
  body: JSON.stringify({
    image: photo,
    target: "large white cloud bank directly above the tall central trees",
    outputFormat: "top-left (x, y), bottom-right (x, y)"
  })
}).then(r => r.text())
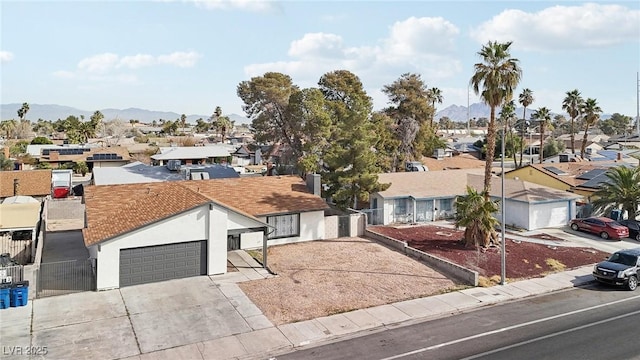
top-left (245, 17), bottom-right (461, 87)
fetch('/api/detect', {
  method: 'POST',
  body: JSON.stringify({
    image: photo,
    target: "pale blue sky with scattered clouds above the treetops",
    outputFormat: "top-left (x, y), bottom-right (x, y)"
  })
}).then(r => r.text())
top-left (0, 0), bottom-right (640, 117)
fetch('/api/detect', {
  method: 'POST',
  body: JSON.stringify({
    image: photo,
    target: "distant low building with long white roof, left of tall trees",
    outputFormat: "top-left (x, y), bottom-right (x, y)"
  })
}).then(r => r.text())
top-left (151, 145), bottom-right (231, 165)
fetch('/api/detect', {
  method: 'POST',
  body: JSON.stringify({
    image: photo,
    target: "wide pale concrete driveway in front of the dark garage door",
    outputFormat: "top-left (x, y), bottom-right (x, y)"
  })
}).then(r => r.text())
top-left (0, 276), bottom-right (273, 359)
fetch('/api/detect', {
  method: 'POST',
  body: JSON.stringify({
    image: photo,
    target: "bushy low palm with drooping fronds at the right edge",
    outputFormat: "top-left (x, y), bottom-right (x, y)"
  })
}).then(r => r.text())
top-left (593, 166), bottom-right (640, 219)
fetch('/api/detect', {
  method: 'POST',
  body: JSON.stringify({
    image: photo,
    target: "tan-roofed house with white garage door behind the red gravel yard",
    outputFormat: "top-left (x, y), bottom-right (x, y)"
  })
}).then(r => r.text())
top-left (371, 169), bottom-right (580, 230)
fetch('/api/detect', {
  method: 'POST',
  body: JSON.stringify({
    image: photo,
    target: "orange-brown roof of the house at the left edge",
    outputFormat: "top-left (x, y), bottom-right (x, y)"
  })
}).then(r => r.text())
top-left (0, 170), bottom-right (51, 201)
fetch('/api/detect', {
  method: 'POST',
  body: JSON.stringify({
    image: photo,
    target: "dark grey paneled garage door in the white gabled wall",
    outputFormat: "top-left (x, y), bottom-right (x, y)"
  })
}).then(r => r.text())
top-left (120, 241), bottom-right (207, 287)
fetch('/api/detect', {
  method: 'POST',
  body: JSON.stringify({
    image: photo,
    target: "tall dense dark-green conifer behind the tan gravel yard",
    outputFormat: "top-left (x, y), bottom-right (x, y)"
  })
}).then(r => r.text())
top-left (318, 70), bottom-right (389, 208)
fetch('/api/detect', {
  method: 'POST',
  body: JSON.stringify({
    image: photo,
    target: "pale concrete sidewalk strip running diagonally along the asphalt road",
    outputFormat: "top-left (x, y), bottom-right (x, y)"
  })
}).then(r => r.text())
top-left (122, 263), bottom-right (593, 360)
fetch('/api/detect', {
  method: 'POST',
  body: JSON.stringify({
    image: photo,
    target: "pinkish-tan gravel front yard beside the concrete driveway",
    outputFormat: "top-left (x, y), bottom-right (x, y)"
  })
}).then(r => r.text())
top-left (239, 238), bottom-right (461, 325)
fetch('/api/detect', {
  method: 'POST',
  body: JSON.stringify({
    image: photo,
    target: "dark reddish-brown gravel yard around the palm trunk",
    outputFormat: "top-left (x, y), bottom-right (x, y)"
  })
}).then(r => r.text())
top-left (372, 225), bottom-right (609, 281)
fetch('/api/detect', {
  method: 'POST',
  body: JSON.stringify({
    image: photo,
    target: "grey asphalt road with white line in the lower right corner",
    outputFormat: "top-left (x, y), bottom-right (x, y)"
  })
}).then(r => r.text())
top-left (274, 284), bottom-right (640, 360)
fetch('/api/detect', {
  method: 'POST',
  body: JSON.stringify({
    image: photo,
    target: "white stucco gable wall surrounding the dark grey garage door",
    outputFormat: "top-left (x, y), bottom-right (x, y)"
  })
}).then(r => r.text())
top-left (89, 205), bottom-right (227, 290)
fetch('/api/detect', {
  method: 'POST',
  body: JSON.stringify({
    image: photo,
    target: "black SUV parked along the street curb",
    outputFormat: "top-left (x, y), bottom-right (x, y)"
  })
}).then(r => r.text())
top-left (593, 248), bottom-right (640, 291)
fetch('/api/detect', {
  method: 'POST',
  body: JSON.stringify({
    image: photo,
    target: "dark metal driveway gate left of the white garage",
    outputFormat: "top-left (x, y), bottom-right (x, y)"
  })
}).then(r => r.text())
top-left (36, 260), bottom-right (96, 298)
